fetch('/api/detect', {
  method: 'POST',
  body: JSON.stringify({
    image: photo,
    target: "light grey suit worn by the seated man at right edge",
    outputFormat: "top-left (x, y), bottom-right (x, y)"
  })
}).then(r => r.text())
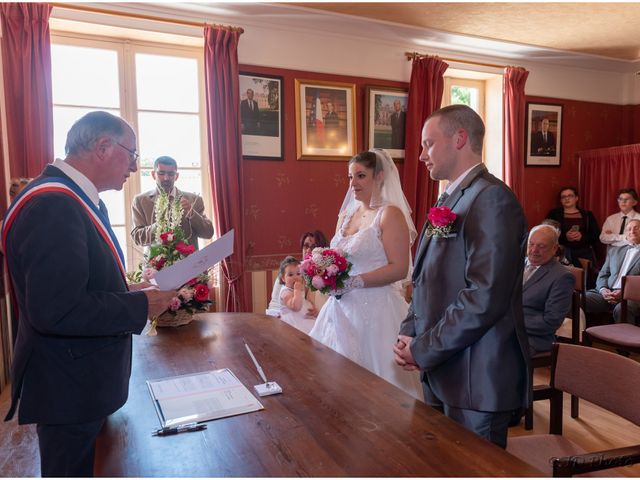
top-left (586, 245), bottom-right (640, 323)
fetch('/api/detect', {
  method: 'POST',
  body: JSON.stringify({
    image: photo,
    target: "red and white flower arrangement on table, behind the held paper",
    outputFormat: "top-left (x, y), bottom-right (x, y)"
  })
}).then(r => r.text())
top-left (127, 191), bottom-right (211, 335)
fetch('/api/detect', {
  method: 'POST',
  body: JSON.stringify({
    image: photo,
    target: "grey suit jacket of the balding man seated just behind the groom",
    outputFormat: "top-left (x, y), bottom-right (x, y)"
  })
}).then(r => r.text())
top-left (522, 259), bottom-right (575, 352)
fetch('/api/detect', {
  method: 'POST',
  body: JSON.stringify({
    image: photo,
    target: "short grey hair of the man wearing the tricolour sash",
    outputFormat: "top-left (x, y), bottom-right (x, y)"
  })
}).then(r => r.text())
top-left (64, 111), bottom-right (128, 155)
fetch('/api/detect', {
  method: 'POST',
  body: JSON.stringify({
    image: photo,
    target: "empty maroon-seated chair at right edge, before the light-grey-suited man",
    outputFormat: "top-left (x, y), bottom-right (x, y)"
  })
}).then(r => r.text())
top-left (583, 275), bottom-right (640, 353)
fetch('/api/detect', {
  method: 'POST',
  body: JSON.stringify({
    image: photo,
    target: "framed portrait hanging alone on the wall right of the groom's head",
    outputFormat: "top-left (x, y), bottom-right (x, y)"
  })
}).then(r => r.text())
top-left (525, 103), bottom-right (562, 167)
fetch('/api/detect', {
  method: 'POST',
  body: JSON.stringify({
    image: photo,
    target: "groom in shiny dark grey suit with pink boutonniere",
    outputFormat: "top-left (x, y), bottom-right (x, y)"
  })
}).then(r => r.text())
top-left (394, 105), bottom-right (529, 448)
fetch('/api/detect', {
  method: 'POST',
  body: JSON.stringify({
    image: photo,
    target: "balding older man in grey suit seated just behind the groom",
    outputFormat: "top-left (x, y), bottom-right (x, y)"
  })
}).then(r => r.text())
top-left (522, 225), bottom-right (575, 355)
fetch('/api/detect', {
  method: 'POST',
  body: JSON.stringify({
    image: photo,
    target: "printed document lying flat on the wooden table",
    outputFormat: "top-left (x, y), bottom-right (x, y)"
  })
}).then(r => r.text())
top-left (147, 368), bottom-right (264, 427)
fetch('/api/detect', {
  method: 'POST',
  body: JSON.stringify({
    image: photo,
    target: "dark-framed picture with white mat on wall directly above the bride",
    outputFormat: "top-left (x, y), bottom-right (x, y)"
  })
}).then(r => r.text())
top-left (364, 85), bottom-right (409, 158)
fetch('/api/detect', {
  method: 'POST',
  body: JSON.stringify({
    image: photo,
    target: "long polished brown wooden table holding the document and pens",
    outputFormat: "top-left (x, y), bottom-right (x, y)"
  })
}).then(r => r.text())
top-left (0, 313), bottom-right (541, 477)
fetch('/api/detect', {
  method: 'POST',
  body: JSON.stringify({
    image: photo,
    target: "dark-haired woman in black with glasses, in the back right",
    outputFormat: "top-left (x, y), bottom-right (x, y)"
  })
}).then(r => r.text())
top-left (547, 187), bottom-right (600, 267)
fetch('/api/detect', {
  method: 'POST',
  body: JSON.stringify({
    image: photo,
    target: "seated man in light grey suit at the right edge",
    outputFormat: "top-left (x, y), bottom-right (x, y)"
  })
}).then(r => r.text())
top-left (586, 219), bottom-right (640, 323)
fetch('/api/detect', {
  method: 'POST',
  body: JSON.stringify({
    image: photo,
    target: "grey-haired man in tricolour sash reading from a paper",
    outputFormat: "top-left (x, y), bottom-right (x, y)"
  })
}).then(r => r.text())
top-left (2, 112), bottom-right (175, 477)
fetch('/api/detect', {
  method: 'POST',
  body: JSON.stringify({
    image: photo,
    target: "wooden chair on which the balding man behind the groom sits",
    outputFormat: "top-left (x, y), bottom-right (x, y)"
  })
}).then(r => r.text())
top-left (524, 266), bottom-right (586, 430)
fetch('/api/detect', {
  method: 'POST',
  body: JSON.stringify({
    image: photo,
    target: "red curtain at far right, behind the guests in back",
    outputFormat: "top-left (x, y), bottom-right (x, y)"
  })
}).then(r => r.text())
top-left (578, 144), bottom-right (640, 232)
